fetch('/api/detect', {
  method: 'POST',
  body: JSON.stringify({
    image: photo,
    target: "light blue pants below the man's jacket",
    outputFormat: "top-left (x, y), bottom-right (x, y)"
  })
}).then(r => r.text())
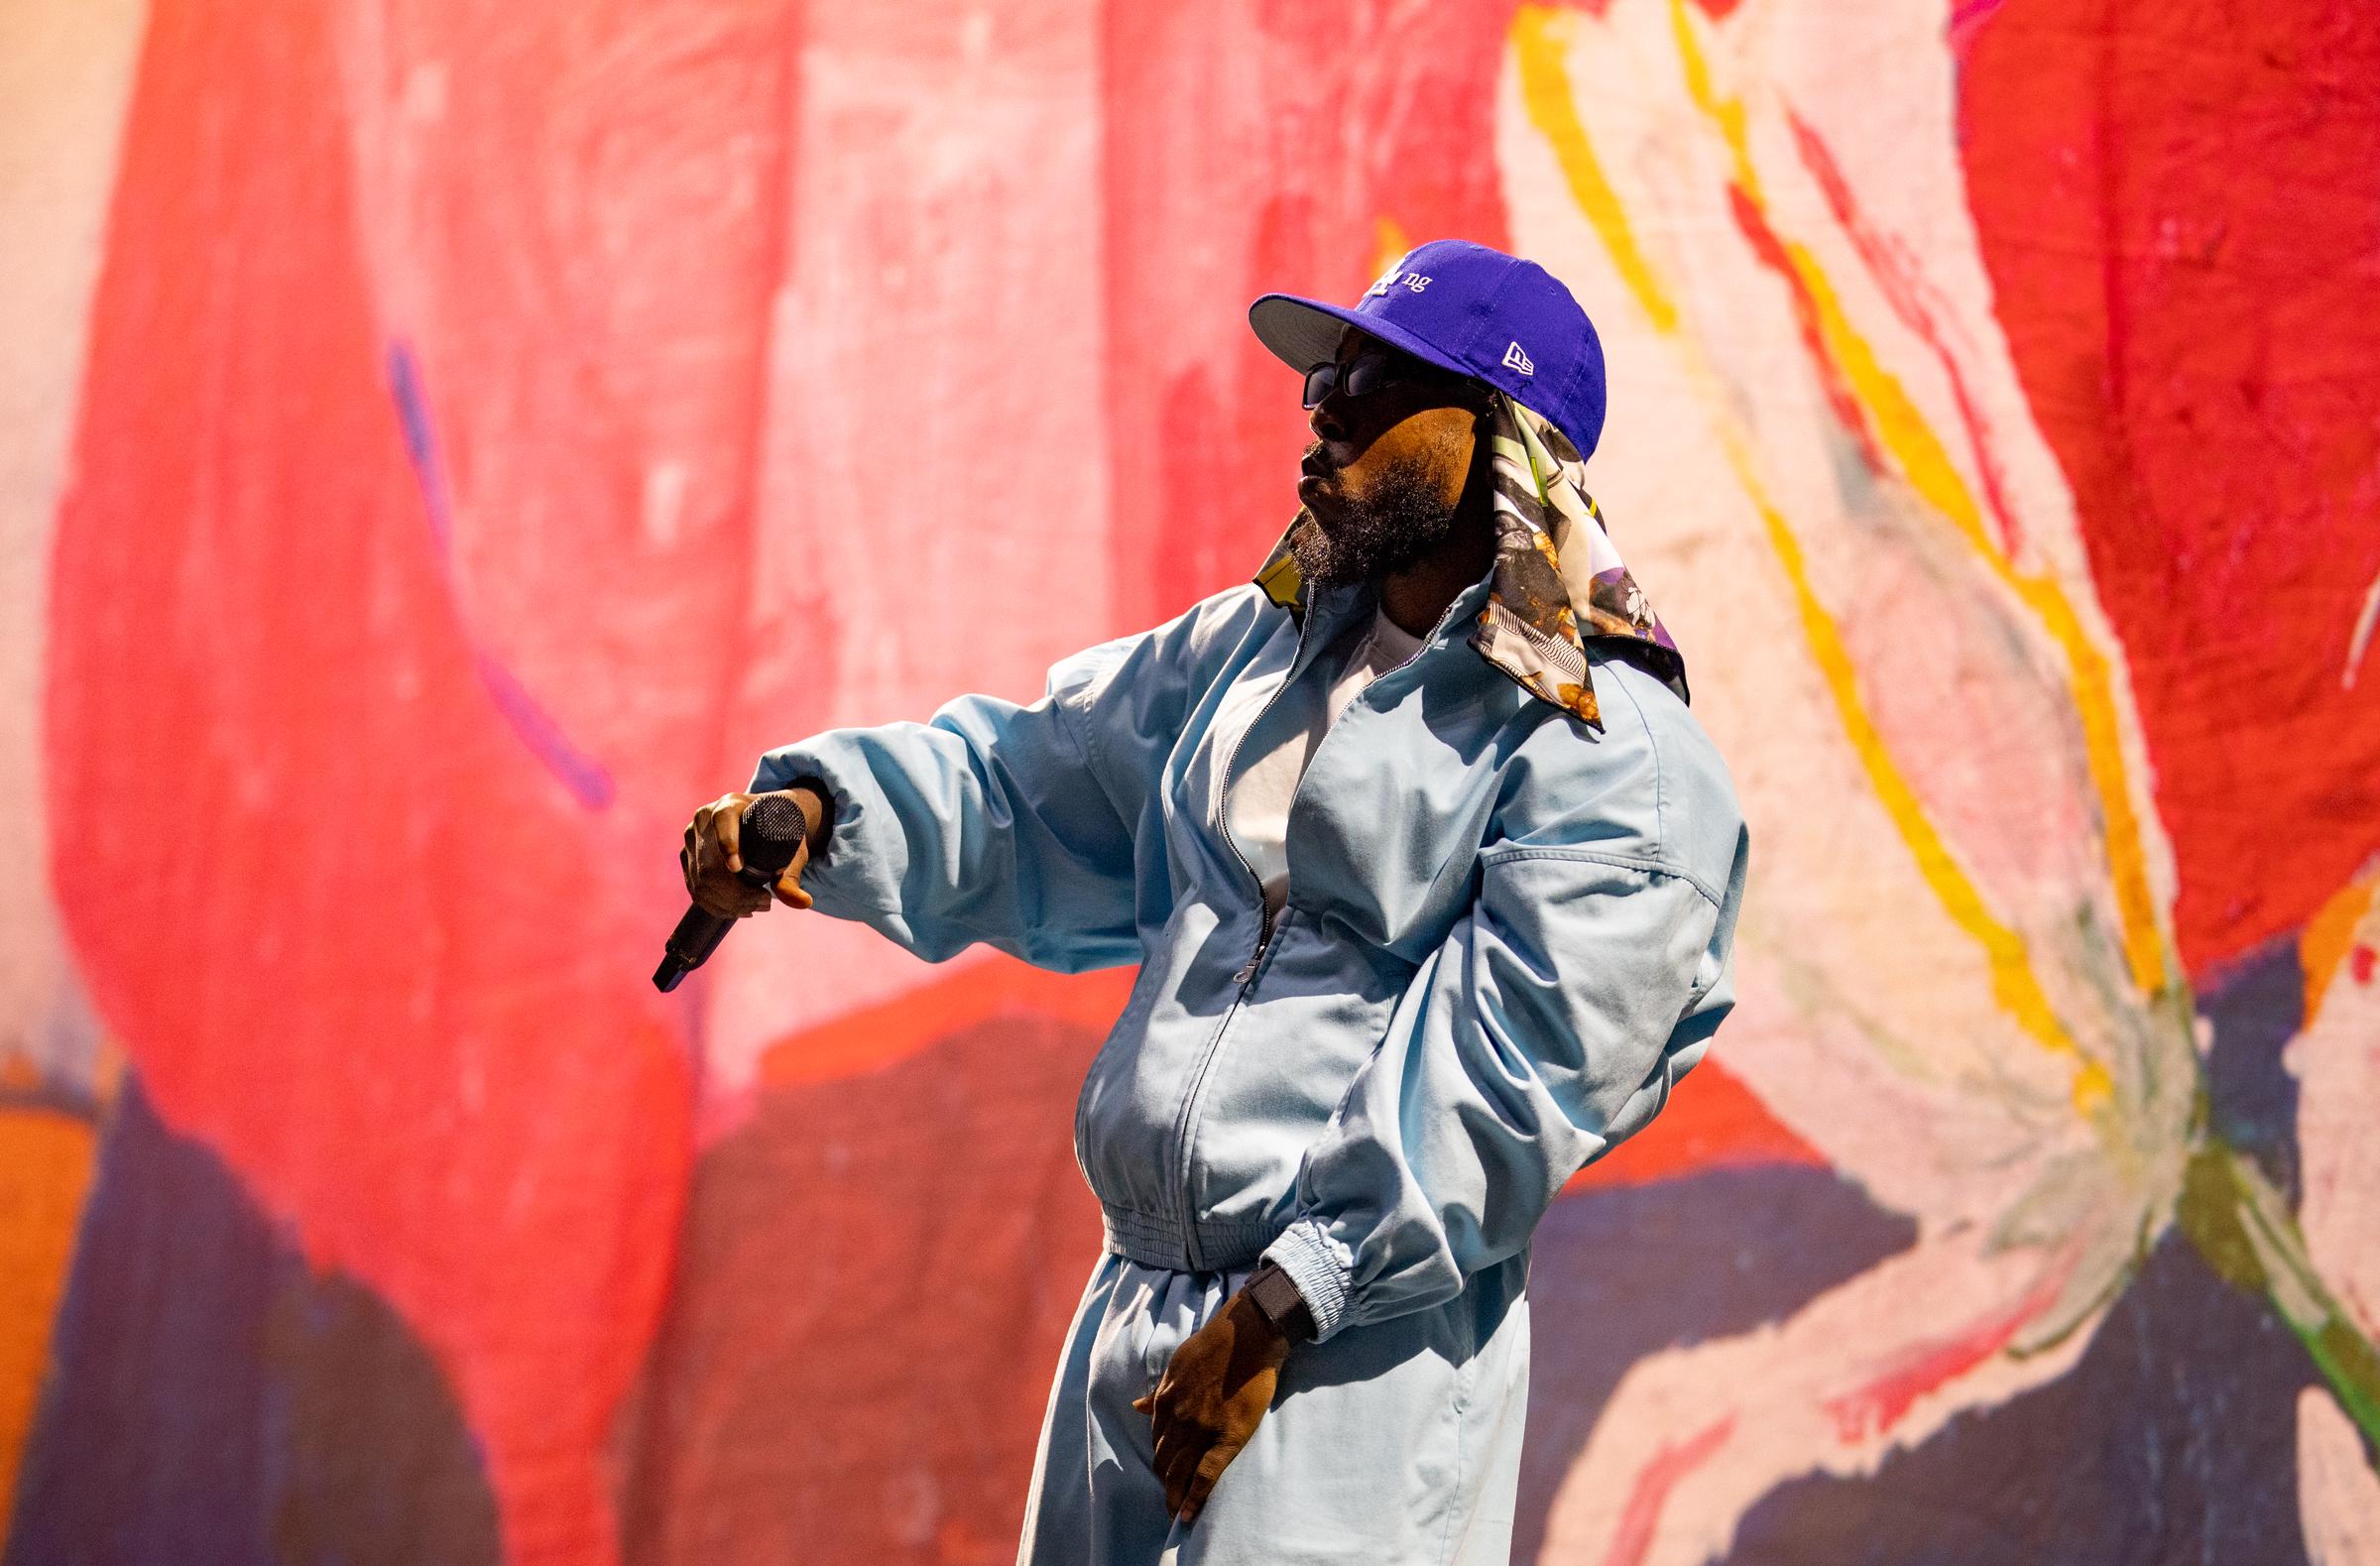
top-left (1016, 1252), bottom-right (1528, 1566)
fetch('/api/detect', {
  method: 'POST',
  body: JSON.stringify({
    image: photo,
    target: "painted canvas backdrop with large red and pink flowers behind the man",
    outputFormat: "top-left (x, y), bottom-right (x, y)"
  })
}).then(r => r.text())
top-left (0, 0), bottom-right (2380, 1566)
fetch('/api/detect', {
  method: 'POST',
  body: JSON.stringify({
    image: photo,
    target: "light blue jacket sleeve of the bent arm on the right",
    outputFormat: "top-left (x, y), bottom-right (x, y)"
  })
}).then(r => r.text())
top-left (1266, 794), bottom-right (1744, 1338)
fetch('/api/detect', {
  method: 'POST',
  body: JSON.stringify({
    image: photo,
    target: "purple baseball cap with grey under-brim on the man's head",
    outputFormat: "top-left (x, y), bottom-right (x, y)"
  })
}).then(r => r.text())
top-left (1248, 240), bottom-right (1605, 457)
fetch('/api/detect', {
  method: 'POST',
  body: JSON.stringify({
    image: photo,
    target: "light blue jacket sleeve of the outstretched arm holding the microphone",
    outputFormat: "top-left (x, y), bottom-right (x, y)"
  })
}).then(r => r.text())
top-left (752, 594), bottom-right (1228, 973)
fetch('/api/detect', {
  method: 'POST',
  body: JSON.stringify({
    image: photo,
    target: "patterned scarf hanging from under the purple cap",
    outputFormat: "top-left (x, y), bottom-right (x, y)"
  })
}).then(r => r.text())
top-left (1256, 393), bottom-right (1688, 731)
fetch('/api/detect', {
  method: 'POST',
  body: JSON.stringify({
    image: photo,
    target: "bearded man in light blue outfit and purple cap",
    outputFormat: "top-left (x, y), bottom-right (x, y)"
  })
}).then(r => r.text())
top-left (685, 240), bottom-right (1747, 1566)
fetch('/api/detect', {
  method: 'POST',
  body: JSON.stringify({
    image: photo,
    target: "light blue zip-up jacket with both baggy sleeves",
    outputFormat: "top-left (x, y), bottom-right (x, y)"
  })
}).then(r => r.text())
top-left (752, 566), bottom-right (1747, 1338)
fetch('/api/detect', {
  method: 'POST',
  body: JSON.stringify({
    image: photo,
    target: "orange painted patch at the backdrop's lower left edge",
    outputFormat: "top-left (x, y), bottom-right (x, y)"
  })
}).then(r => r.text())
top-left (0, 1090), bottom-right (93, 1520)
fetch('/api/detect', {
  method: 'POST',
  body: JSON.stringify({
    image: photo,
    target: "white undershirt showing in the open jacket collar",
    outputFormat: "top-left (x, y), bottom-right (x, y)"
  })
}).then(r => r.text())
top-left (1216, 612), bottom-right (1423, 913)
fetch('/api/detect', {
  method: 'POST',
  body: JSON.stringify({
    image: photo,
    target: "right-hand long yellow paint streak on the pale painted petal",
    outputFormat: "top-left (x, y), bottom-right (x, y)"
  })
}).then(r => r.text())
top-left (1671, 0), bottom-right (2171, 995)
